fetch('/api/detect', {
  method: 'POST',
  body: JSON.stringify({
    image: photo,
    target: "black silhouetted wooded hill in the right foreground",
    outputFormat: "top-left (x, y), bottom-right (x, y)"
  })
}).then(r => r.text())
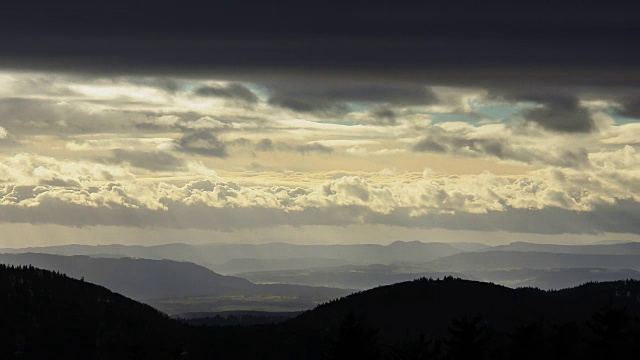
top-left (242, 278), bottom-right (640, 359)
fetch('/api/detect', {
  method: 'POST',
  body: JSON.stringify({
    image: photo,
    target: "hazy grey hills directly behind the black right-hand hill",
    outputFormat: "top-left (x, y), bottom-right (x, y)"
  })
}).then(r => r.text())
top-left (235, 242), bottom-right (640, 289)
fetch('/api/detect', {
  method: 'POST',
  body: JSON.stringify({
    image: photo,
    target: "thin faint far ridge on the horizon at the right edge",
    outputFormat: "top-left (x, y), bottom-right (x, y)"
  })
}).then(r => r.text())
top-left (485, 241), bottom-right (640, 255)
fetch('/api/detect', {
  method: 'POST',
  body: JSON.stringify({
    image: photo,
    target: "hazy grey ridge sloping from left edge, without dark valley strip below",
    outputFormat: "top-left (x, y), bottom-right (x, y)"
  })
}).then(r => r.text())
top-left (0, 253), bottom-right (350, 311)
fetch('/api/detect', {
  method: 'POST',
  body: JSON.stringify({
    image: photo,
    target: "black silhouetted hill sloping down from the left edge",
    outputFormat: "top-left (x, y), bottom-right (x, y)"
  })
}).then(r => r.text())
top-left (0, 265), bottom-right (198, 359)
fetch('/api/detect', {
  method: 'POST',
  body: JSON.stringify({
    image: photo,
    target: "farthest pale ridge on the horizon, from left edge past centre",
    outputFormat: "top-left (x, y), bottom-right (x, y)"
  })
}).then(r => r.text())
top-left (0, 241), bottom-right (487, 274)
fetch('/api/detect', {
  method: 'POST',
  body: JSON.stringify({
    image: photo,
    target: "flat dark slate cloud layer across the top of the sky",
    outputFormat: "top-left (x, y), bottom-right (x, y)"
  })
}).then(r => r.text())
top-left (0, 0), bottom-right (640, 90)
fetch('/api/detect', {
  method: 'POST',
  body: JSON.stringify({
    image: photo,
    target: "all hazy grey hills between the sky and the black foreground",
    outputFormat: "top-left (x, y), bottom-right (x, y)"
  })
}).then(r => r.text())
top-left (0, 241), bottom-right (640, 296)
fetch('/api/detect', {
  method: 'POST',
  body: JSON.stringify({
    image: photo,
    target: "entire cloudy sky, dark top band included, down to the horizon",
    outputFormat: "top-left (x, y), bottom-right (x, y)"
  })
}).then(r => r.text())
top-left (0, 1), bottom-right (640, 247)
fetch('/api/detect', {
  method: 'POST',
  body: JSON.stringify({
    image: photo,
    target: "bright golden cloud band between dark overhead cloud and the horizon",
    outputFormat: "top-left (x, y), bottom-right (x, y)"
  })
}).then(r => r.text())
top-left (0, 72), bottom-right (640, 243)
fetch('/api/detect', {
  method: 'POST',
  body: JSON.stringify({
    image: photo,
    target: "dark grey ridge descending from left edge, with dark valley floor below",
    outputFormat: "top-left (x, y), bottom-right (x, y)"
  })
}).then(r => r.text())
top-left (0, 253), bottom-right (351, 314)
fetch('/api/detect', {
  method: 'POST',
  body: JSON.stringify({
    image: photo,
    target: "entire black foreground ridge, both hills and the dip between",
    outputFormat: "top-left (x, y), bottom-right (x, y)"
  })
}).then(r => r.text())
top-left (0, 265), bottom-right (640, 359)
